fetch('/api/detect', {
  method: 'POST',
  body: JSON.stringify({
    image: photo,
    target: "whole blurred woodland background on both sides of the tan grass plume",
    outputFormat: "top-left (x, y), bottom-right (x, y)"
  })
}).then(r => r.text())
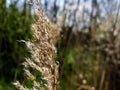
top-left (0, 0), bottom-right (120, 90)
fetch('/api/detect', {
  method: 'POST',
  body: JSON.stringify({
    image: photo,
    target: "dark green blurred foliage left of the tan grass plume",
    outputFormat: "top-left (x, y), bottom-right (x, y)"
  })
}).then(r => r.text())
top-left (0, 0), bottom-right (32, 90)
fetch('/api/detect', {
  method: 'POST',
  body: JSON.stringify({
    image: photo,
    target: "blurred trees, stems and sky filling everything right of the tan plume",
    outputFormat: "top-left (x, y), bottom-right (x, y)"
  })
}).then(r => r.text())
top-left (41, 0), bottom-right (120, 90)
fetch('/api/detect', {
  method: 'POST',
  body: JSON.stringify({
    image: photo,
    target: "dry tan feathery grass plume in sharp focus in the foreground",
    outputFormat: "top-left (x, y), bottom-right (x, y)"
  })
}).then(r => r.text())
top-left (14, 0), bottom-right (60, 90)
